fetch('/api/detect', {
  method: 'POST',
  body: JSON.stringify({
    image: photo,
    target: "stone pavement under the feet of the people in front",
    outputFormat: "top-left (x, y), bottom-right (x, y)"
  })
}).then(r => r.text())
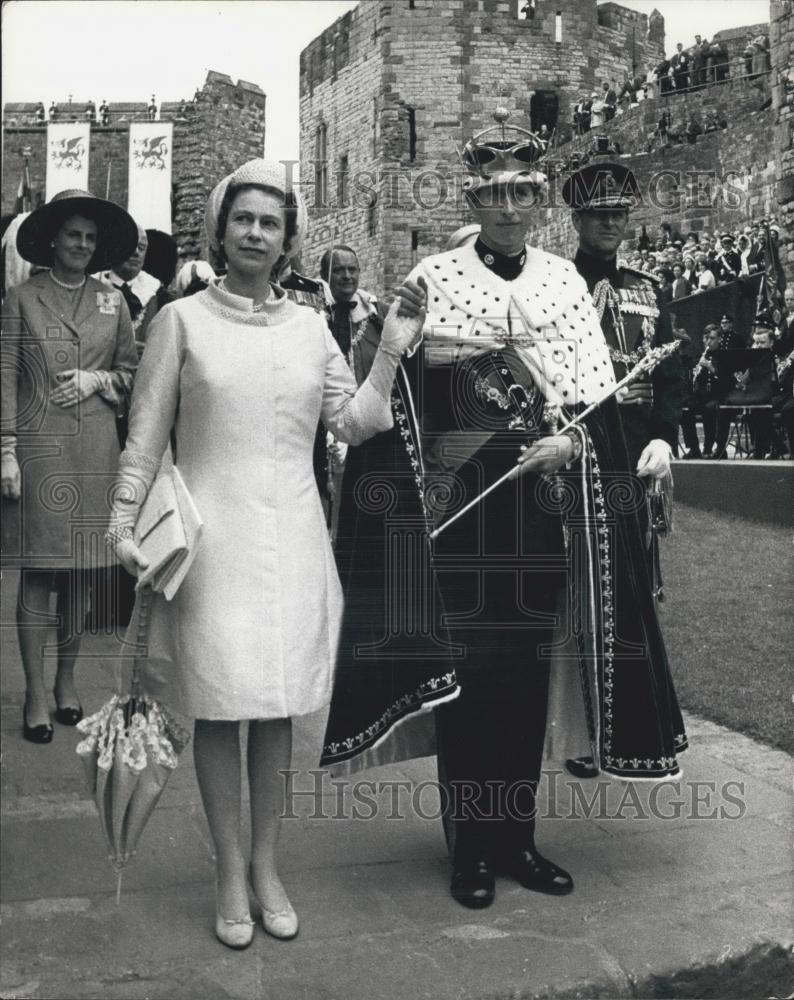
top-left (0, 574), bottom-right (794, 1000)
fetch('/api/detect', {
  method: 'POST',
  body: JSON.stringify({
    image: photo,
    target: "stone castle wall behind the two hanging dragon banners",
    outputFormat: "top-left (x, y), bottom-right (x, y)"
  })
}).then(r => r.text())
top-left (2, 70), bottom-right (265, 259)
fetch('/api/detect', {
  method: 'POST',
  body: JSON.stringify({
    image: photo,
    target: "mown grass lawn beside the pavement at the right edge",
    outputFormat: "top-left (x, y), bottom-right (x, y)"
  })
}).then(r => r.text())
top-left (661, 504), bottom-right (794, 753)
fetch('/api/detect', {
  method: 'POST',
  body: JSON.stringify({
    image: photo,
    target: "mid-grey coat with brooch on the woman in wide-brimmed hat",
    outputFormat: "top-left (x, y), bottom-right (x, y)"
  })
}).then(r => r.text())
top-left (2, 272), bottom-right (138, 569)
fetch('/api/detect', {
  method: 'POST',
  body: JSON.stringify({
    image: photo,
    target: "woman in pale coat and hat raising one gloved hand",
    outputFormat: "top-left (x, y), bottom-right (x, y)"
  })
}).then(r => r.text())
top-left (109, 160), bottom-right (424, 948)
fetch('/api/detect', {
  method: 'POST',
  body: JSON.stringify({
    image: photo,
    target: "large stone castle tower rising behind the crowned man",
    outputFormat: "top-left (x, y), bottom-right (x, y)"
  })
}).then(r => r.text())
top-left (300, 0), bottom-right (664, 292)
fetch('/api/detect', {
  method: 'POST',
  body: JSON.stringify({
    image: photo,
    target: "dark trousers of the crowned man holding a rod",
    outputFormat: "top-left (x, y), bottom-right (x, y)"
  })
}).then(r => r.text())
top-left (436, 458), bottom-right (566, 858)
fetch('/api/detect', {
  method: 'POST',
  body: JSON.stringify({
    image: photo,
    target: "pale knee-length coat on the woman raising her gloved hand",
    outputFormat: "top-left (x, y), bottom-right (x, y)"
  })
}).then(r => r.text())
top-left (121, 283), bottom-right (396, 720)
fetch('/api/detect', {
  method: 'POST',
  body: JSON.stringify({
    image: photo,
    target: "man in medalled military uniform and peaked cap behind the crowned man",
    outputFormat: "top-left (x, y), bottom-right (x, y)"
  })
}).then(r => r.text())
top-left (562, 148), bottom-right (684, 777)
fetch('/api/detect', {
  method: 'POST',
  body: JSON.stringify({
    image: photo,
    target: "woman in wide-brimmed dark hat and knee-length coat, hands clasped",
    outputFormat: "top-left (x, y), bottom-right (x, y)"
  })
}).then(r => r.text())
top-left (1, 191), bottom-right (137, 743)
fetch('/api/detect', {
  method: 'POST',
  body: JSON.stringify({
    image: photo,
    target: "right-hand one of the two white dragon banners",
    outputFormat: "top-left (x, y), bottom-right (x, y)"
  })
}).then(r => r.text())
top-left (127, 122), bottom-right (173, 233)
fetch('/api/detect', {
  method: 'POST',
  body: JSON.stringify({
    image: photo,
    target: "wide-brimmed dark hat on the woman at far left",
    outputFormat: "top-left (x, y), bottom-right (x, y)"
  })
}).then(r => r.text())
top-left (17, 190), bottom-right (138, 274)
